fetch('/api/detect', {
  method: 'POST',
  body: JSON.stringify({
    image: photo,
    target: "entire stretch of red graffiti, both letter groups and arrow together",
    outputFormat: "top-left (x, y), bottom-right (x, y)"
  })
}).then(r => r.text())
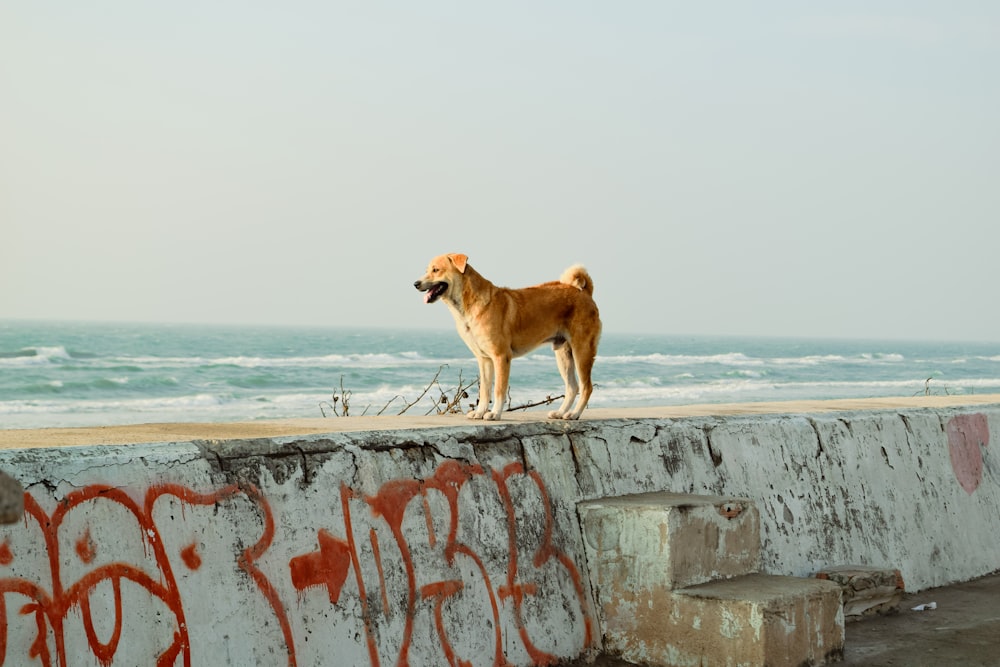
top-left (0, 461), bottom-right (593, 667)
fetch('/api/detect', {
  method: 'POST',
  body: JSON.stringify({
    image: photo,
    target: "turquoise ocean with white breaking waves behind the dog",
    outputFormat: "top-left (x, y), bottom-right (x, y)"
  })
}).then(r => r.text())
top-left (0, 321), bottom-right (1000, 429)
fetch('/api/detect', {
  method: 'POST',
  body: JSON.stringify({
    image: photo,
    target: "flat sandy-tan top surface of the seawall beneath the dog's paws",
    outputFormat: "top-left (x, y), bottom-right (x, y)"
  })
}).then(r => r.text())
top-left (0, 394), bottom-right (1000, 449)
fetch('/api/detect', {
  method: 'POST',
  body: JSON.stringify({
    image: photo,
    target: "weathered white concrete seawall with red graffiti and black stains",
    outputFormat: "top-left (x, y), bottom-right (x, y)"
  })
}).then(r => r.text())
top-left (0, 405), bottom-right (1000, 666)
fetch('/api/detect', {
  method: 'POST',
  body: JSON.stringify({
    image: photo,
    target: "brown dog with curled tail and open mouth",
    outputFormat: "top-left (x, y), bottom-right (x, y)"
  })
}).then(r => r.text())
top-left (413, 254), bottom-right (601, 420)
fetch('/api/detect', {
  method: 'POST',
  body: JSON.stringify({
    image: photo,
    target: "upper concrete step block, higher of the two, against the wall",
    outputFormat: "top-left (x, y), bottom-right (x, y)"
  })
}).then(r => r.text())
top-left (577, 493), bottom-right (760, 592)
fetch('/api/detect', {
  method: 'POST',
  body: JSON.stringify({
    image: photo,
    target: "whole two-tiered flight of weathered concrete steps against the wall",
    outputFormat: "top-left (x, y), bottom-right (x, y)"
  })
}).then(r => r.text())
top-left (578, 493), bottom-right (844, 667)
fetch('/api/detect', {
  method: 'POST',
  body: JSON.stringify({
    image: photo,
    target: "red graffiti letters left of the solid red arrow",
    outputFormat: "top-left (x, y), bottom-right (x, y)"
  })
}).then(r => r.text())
top-left (0, 484), bottom-right (291, 666)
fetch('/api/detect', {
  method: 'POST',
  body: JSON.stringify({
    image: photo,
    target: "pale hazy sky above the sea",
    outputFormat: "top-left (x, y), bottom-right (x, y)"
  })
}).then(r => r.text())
top-left (0, 0), bottom-right (1000, 341)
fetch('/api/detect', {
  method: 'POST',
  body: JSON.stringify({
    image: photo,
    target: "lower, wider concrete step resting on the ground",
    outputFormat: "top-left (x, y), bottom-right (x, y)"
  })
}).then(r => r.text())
top-left (604, 574), bottom-right (844, 667)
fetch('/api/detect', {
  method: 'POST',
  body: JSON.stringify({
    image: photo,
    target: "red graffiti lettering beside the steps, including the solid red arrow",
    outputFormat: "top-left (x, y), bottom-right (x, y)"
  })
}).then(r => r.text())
top-left (289, 461), bottom-right (593, 667)
